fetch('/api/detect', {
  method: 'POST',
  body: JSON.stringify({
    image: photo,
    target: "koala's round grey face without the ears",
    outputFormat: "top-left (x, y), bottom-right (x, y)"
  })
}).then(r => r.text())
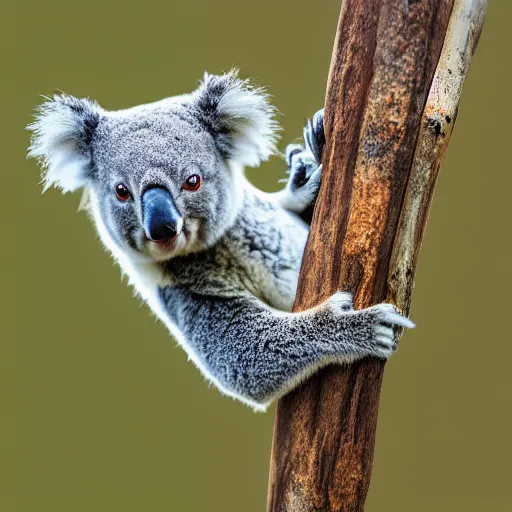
top-left (90, 104), bottom-right (239, 260)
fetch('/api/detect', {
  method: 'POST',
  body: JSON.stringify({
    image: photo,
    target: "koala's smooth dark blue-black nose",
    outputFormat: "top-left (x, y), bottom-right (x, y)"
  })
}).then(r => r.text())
top-left (142, 188), bottom-right (183, 241)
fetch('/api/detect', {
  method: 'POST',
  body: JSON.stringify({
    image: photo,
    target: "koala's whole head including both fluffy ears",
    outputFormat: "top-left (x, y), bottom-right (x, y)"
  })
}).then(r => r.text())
top-left (28, 71), bottom-right (277, 261)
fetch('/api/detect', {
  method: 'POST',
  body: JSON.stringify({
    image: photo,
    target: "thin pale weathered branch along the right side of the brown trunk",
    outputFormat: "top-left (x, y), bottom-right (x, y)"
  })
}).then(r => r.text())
top-left (388, 0), bottom-right (487, 314)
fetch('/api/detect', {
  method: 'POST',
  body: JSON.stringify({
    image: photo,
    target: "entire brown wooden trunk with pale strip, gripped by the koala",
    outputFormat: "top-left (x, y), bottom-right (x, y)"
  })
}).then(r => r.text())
top-left (268, 0), bottom-right (486, 512)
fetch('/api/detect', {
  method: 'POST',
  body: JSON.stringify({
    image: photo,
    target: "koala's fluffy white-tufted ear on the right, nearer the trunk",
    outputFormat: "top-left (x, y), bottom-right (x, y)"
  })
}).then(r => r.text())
top-left (192, 70), bottom-right (279, 167)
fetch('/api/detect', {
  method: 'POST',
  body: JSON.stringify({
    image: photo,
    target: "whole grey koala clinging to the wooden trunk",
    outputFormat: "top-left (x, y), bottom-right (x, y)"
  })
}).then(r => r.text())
top-left (28, 71), bottom-right (414, 410)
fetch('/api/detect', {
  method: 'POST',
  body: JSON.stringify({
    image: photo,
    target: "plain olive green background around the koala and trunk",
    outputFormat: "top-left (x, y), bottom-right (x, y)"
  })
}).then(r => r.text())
top-left (0, 0), bottom-right (512, 512)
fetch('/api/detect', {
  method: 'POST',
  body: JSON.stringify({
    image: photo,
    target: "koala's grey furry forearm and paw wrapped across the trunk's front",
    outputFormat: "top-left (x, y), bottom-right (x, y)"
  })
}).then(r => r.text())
top-left (160, 288), bottom-right (413, 410)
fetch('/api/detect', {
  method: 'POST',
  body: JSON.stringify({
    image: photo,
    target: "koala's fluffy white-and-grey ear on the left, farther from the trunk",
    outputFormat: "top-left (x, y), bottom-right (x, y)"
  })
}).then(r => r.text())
top-left (27, 94), bottom-right (102, 193)
